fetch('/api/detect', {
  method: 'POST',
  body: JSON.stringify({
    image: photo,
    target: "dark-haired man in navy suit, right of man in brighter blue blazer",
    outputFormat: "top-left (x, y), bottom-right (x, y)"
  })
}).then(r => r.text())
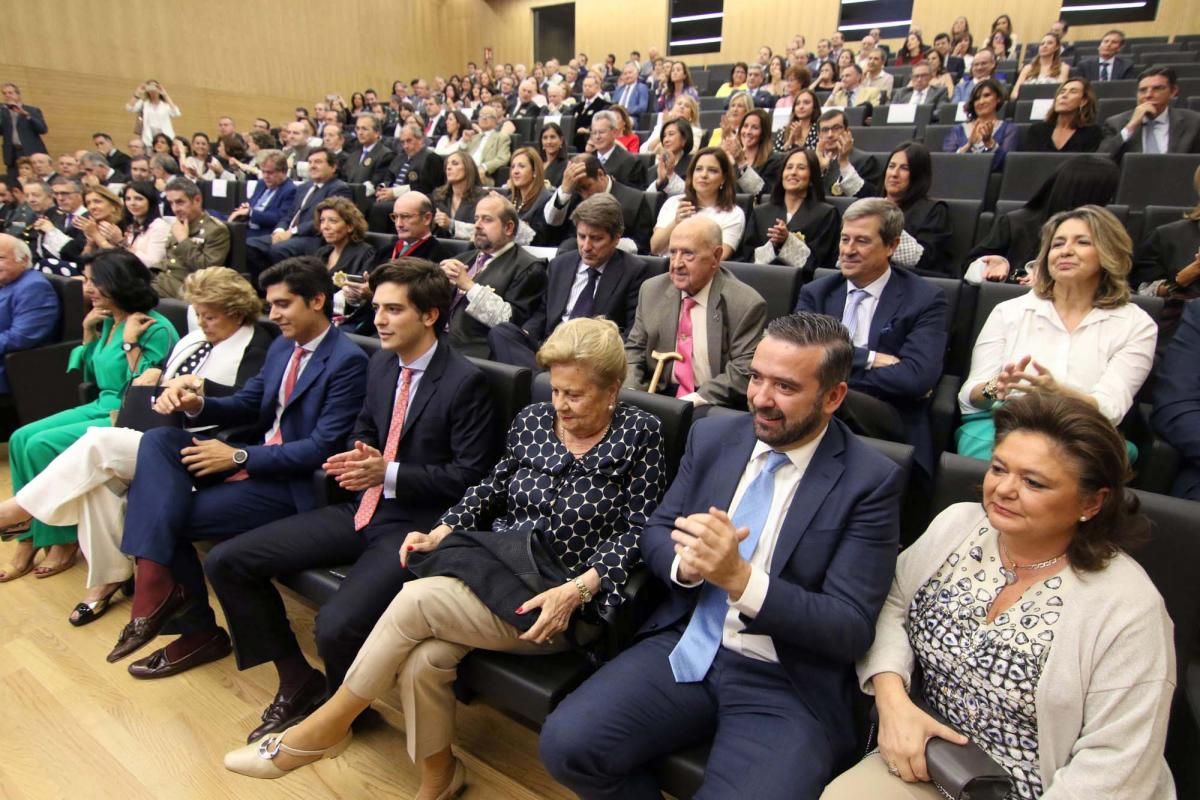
top-left (246, 148), bottom-right (354, 275)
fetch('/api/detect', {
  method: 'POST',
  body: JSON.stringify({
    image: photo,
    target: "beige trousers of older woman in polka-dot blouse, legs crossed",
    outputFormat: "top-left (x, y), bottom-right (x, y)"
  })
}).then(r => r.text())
top-left (346, 577), bottom-right (568, 763)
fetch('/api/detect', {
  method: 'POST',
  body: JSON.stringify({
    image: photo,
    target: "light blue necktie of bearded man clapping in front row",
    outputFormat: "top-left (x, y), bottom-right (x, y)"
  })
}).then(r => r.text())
top-left (668, 450), bottom-right (791, 684)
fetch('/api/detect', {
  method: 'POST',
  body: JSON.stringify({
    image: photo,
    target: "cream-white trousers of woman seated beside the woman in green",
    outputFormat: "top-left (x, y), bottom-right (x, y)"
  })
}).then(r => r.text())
top-left (17, 428), bottom-right (142, 587)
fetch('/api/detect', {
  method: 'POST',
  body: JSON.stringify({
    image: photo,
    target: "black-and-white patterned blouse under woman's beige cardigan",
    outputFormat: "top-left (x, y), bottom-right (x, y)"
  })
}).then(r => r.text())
top-left (908, 525), bottom-right (1078, 800)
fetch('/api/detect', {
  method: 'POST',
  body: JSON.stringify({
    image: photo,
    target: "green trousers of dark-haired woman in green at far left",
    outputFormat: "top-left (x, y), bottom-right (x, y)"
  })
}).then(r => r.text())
top-left (8, 403), bottom-right (112, 547)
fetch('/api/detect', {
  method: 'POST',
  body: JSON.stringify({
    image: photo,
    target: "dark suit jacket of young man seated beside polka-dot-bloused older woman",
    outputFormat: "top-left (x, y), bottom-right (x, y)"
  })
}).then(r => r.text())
top-left (347, 341), bottom-right (503, 530)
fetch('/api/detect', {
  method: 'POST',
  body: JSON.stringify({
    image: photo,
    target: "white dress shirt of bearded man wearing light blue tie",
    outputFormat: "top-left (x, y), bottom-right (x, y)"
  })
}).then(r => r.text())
top-left (671, 425), bottom-right (829, 663)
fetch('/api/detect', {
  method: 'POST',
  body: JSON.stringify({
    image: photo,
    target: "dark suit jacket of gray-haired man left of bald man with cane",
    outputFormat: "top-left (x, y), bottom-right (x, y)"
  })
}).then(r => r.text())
top-left (523, 249), bottom-right (647, 345)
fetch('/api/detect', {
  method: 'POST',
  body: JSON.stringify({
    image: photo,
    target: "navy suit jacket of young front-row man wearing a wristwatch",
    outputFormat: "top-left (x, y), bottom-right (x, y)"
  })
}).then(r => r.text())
top-left (196, 325), bottom-right (367, 511)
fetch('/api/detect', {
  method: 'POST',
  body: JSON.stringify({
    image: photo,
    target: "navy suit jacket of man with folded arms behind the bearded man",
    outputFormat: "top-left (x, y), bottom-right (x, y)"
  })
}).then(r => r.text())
top-left (796, 267), bottom-right (948, 475)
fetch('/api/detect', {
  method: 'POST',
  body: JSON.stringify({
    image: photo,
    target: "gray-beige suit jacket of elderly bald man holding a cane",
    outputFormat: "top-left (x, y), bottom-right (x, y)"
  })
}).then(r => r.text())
top-left (625, 267), bottom-right (767, 409)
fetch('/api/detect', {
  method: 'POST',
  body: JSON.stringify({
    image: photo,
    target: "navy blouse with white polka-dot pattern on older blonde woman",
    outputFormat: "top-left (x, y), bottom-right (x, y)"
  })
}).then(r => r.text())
top-left (439, 403), bottom-right (666, 606)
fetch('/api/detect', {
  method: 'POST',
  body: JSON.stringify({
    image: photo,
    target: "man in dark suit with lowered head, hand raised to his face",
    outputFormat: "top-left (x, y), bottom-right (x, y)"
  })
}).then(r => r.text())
top-left (545, 154), bottom-right (654, 253)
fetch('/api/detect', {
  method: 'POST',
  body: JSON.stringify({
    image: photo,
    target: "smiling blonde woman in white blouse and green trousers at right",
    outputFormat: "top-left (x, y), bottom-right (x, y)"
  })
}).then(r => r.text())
top-left (955, 205), bottom-right (1158, 459)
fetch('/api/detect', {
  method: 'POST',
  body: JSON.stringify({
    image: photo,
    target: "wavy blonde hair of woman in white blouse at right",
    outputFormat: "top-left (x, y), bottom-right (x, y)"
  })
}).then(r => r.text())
top-left (1033, 205), bottom-right (1133, 308)
